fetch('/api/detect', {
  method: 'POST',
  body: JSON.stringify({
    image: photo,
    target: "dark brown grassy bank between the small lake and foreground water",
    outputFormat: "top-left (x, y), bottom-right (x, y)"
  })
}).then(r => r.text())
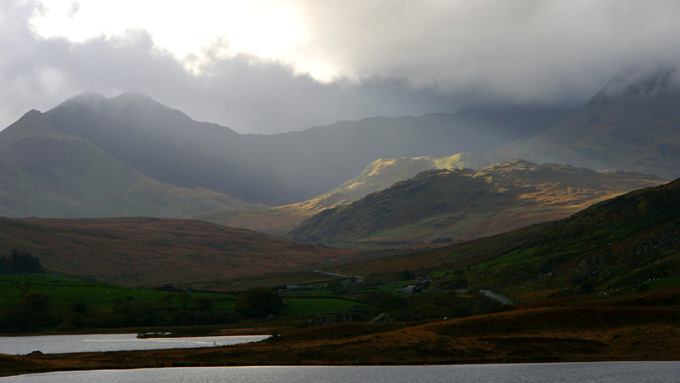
top-left (0, 307), bottom-right (680, 376)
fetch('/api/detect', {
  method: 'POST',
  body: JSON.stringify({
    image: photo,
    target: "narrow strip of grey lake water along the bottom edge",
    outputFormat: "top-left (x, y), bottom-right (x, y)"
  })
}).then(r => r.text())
top-left (0, 362), bottom-right (680, 383)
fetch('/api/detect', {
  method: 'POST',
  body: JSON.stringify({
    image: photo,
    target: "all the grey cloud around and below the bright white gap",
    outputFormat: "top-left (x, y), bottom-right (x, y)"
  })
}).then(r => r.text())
top-left (0, 0), bottom-right (680, 133)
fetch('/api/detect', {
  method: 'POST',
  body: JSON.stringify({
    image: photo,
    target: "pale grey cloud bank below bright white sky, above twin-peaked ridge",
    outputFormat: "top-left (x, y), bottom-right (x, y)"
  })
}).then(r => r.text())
top-left (0, 2), bottom-right (462, 133)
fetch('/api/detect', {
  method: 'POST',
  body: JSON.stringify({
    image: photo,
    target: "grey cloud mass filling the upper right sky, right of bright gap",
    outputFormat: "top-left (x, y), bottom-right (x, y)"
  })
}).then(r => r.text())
top-left (294, 0), bottom-right (680, 101)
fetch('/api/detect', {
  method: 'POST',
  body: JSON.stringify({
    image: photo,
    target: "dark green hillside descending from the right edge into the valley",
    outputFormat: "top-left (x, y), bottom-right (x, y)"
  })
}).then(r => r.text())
top-left (340, 180), bottom-right (680, 300)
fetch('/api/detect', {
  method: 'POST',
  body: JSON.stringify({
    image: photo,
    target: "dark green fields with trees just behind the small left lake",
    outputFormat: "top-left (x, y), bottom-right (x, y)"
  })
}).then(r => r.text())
top-left (0, 273), bottom-right (372, 333)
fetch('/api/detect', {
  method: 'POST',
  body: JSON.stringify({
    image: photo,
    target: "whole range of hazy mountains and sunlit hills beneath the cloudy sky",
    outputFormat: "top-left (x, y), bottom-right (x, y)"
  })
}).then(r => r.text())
top-left (0, 71), bottom-right (680, 262)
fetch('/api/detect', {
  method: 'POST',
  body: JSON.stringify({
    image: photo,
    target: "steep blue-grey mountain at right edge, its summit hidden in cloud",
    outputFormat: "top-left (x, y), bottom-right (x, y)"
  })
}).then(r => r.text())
top-left (494, 71), bottom-right (680, 179)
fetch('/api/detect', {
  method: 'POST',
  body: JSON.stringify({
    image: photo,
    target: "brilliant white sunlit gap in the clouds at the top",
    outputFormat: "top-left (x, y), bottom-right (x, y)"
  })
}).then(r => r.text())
top-left (30, 0), bottom-right (335, 80)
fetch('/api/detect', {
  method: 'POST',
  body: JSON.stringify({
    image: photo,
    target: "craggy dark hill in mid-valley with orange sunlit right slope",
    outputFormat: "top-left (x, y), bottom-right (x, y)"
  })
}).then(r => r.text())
top-left (290, 160), bottom-right (663, 247)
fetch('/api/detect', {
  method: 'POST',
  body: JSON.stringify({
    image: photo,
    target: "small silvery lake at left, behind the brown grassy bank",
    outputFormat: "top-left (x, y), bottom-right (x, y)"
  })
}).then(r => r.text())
top-left (0, 334), bottom-right (269, 355)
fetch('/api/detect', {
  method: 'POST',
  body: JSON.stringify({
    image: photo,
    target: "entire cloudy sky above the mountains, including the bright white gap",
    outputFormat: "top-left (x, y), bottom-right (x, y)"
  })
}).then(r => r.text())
top-left (0, 0), bottom-right (680, 134)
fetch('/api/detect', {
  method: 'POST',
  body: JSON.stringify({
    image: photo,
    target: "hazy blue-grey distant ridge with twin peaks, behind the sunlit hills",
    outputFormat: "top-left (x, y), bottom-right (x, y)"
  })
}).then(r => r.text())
top-left (6, 94), bottom-right (567, 206)
